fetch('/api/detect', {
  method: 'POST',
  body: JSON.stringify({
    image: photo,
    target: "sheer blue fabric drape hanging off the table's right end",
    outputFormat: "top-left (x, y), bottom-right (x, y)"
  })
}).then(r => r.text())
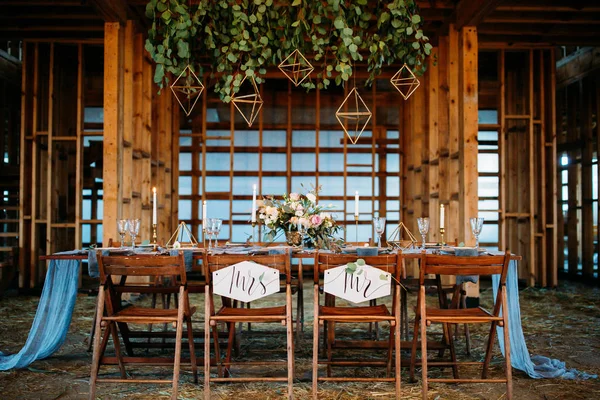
top-left (492, 260), bottom-right (598, 379)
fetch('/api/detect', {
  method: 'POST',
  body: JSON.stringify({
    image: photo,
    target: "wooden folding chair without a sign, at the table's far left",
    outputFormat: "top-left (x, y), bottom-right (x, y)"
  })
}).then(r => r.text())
top-left (89, 252), bottom-right (198, 399)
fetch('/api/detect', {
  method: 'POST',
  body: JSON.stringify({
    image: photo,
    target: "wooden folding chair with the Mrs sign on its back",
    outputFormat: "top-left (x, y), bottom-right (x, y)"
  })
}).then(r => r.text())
top-left (204, 253), bottom-right (294, 399)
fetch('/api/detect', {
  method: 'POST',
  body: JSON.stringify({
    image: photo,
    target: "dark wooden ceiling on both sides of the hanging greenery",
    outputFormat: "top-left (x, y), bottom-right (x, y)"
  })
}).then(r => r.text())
top-left (0, 0), bottom-right (600, 46)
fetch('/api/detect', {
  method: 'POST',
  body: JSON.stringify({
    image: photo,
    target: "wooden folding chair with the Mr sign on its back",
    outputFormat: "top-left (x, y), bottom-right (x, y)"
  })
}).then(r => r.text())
top-left (312, 253), bottom-right (403, 399)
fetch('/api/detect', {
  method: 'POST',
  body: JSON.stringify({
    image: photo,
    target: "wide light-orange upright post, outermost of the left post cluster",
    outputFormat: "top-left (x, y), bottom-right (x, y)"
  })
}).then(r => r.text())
top-left (102, 22), bottom-right (123, 247)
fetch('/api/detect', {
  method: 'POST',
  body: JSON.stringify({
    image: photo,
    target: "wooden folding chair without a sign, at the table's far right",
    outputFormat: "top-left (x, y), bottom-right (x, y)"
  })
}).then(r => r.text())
top-left (411, 251), bottom-right (512, 399)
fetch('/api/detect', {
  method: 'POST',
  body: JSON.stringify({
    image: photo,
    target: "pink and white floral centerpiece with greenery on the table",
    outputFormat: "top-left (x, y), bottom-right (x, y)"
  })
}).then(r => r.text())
top-left (257, 188), bottom-right (342, 249)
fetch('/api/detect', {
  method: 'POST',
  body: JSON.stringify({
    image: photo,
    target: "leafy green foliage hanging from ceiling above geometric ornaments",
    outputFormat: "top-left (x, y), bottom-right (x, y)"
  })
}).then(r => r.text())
top-left (146, 0), bottom-right (432, 102)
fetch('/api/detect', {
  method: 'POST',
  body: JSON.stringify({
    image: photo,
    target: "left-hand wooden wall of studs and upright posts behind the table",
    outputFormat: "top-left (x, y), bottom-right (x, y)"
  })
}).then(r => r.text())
top-left (19, 21), bottom-right (173, 288)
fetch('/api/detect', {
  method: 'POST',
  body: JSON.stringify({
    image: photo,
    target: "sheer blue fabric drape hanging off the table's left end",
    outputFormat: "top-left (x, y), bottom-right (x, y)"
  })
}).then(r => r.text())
top-left (0, 251), bottom-right (80, 371)
